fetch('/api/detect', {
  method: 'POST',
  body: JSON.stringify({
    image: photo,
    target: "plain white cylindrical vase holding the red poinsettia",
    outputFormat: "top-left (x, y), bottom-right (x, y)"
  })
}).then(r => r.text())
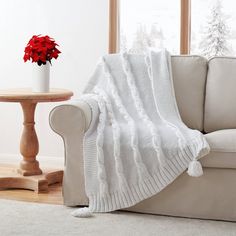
top-left (32, 62), bottom-right (50, 93)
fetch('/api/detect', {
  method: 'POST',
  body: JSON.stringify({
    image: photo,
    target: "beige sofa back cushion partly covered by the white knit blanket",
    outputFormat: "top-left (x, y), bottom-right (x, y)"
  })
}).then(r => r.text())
top-left (171, 56), bottom-right (207, 131)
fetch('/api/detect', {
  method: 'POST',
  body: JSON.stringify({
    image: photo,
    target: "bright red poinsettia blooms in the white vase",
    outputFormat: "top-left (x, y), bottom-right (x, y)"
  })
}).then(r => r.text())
top-left (23, 35), bottom-right (61, 66)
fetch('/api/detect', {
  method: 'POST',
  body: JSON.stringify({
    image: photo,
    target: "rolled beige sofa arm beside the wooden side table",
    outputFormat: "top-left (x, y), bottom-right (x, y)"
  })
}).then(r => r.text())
top-left (49, 101), bottom-right (92, 206)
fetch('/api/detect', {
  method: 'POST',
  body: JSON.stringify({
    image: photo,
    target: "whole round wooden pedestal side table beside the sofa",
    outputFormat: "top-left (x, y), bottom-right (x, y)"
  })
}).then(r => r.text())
top-left (0, 89), bottom-right (73, 192)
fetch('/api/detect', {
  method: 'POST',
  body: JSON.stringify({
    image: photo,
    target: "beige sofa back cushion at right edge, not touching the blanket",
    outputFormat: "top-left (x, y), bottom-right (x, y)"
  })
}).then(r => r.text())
top-left (204, 57), bottom-right (236, 132)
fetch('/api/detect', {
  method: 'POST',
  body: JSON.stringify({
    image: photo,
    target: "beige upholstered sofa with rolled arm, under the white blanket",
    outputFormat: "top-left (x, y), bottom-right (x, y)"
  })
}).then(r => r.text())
top-left (50, 56), bottom-right (236, 221)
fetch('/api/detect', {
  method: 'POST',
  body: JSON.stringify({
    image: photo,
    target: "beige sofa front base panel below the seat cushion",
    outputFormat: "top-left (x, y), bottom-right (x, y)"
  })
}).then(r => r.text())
top-left (129, 168), bottom-right (236, 221)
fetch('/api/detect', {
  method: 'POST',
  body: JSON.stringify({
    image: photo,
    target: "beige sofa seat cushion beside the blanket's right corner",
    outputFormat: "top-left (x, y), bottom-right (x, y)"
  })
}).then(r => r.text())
top-left (200, 129), bottom-right (236, 168)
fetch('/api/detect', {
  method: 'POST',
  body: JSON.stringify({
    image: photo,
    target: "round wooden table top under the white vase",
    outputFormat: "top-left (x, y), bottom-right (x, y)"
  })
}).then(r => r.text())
top-left (0, 88), bottom-right (73, 102)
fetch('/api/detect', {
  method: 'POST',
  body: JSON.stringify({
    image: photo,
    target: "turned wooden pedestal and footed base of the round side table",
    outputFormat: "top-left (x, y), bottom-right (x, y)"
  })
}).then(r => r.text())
top-left (0, 101), bottom-right (63, 193)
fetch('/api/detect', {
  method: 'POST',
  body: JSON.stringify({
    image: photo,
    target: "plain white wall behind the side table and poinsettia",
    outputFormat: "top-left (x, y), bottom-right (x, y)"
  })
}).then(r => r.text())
top-left (0, 0), bottom-right (109, 162)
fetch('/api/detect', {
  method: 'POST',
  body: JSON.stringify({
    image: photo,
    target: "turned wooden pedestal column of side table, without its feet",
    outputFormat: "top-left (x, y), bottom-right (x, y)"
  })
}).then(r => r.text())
top-left (18, 101), bottom-right (42, 176)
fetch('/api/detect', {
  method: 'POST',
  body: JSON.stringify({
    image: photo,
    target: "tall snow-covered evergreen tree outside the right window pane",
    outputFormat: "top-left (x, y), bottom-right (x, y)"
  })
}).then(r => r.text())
top-left (200, 0), bottom-right (230, 58)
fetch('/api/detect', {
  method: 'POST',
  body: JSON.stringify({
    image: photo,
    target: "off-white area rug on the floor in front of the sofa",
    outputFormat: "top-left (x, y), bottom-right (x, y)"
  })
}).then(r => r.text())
top-left (0, 200), bottom-right (236, 236)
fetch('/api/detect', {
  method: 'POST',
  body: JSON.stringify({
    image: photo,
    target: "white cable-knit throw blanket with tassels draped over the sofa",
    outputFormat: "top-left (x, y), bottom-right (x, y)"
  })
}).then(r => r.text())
top-left (77, 50), bottom-right (209, 216)
